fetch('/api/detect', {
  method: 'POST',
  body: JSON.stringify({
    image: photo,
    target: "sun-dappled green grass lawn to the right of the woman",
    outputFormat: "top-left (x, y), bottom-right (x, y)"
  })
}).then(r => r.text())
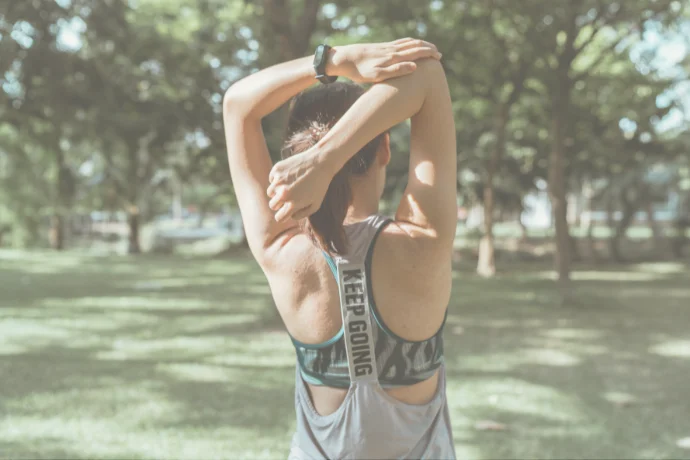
top-left (445, 260), bottom-right (690, 458)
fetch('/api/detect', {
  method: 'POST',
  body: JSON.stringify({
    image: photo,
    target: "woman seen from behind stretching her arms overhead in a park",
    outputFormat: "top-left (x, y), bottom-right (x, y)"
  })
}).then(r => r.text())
top-left (224, 39), bottom-right (456, 459)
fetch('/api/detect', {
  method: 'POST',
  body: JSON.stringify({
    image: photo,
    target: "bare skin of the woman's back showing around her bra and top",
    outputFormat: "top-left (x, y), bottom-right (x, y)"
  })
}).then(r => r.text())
top-left (271, 222), bottom-right (451, 415)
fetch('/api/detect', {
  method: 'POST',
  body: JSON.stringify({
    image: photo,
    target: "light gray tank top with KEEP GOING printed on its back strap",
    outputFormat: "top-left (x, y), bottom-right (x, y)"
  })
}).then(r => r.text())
top-left (288, 216), bottom-right (456, 460)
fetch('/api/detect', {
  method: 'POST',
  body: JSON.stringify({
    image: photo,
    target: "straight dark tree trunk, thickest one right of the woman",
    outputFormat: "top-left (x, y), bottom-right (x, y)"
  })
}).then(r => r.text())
top-left (548, 99), bottom-right (571, 303)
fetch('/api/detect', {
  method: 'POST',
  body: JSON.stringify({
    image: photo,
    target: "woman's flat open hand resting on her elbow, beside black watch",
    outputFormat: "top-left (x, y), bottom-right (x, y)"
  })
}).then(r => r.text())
top-left (326, 38), bottom-right (441, 83)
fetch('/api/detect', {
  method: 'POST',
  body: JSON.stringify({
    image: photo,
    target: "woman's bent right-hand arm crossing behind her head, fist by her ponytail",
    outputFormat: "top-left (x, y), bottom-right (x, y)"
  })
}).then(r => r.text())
top-left (268, 59), bottom-right (457, 253)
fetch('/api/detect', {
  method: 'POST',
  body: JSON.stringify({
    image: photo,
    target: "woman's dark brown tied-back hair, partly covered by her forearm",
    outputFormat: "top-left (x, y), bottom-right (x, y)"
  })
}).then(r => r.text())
top-left (281, 82), bottom-right (385, 254)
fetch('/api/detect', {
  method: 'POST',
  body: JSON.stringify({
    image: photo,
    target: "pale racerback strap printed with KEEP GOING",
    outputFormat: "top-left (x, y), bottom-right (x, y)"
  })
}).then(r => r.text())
top-left (336, 259), bottom-right (378, 383)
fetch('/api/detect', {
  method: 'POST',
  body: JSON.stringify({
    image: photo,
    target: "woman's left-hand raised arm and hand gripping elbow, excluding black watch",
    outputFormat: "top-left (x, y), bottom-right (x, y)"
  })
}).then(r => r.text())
top-left (223, 39), bottom-right (438, 263)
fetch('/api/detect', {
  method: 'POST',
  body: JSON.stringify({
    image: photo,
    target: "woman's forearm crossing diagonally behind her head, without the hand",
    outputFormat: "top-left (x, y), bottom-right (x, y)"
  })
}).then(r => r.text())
top-left (316, 59), bottom-right (443, 173)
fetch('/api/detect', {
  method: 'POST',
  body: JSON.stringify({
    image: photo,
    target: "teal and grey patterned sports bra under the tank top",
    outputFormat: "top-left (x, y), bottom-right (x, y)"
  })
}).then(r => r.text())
top-left (290, 215), bottom-right (448, 388)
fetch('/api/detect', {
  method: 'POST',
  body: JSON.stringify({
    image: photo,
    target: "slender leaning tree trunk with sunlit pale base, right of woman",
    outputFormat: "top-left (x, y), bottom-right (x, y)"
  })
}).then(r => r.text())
top-left (477, 104), bottom-right (508, 278)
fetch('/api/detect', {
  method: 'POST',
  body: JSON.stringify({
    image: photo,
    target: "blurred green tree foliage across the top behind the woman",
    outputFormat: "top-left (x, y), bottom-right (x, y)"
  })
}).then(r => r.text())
top-left (0, 0), bottom-right (690, 252)
